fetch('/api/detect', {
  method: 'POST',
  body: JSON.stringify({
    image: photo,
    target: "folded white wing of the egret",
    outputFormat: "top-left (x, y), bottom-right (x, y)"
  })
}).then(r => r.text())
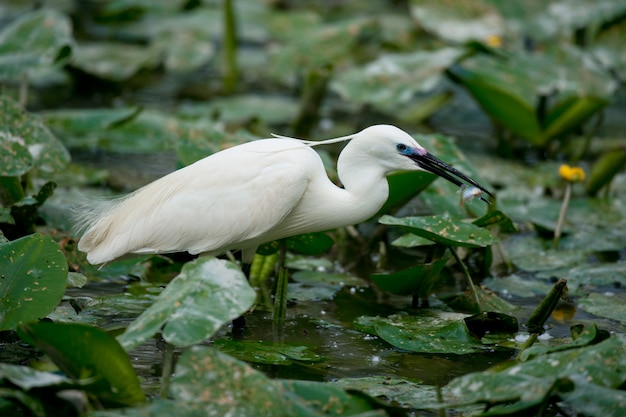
top-left (81, 139), bottom-right (321, 263)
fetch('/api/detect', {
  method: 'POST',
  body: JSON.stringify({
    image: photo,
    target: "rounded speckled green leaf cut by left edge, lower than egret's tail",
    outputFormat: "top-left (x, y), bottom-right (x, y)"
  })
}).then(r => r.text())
top-left (0, 234), bottom-right (67, 330)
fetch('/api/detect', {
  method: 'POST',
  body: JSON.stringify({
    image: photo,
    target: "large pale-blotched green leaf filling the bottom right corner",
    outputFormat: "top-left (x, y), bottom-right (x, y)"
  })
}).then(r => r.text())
top-left (443, 337), bottom-right (626, 417)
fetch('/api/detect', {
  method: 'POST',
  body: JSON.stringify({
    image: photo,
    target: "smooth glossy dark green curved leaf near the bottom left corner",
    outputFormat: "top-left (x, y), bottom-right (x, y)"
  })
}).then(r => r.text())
top-left (18, 321), bottom-right (145, 407)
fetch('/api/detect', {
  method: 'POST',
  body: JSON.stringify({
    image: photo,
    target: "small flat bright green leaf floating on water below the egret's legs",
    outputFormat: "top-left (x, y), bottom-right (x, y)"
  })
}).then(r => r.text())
top-left (213, 339), bottom-right (325, 365)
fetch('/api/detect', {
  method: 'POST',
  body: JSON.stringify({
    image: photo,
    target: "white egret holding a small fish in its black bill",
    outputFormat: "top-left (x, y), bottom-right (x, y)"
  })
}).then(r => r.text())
top-left (77, 125), bottom-right (492, 264)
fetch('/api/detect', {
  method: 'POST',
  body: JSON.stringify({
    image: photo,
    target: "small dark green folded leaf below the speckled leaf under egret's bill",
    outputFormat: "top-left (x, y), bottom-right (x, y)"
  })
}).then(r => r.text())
top-left (370, 258), bottom-right (448, 297)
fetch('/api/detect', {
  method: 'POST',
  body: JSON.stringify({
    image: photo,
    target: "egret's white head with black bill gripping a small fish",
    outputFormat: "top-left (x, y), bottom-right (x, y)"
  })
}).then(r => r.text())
top-left (348, 125), bottom-right (494, 203)
